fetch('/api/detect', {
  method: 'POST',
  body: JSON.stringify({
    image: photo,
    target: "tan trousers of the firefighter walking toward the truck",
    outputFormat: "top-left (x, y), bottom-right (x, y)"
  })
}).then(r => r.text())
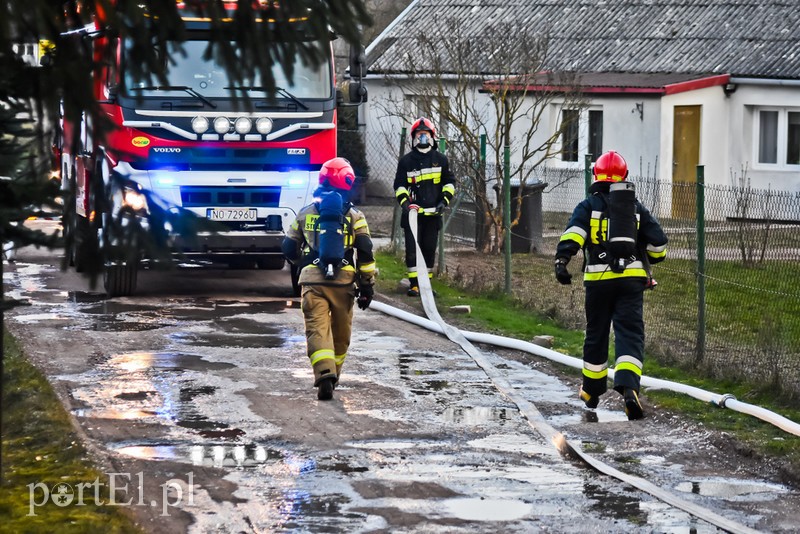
top-left (301, 284), bottom-right (356, 386)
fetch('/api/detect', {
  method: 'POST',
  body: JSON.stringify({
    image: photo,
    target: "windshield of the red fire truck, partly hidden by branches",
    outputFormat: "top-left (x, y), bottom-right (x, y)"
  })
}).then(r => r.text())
top-left (124, 40), bottom-right (333, 99)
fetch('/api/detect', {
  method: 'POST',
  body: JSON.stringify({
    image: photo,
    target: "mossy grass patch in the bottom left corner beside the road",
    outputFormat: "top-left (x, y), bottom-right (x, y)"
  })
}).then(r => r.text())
top-left (0, 332), bottom-right (142, 533)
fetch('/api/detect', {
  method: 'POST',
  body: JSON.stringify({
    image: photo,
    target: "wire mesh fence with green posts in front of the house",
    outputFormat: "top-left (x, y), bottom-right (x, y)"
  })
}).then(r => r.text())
top-left (350, 130), bottom-right (800, 395)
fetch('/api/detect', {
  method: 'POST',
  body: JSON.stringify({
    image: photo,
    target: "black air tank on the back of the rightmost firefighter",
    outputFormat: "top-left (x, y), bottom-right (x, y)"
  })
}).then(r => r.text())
top-left (604, 182), bottom-right (638, 273)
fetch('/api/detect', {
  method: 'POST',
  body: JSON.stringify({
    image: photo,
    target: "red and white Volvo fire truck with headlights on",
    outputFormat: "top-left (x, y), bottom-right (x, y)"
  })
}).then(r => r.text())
top-left (55, 3), bottom-right (366, 296)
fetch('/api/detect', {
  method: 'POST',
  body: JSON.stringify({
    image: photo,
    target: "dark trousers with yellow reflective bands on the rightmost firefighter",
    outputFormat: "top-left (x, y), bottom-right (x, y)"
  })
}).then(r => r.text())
top-left (583, 278), bottom-right (645, 397)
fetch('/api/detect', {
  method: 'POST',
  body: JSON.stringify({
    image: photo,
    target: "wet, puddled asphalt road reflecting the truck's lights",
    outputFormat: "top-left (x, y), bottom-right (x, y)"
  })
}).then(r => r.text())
top-left (3, 221), bottom-right (800, 533)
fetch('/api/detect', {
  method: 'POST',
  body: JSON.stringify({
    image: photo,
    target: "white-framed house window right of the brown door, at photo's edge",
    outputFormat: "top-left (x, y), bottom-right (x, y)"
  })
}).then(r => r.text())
top-left (756, 109), bottom-right (800, 168)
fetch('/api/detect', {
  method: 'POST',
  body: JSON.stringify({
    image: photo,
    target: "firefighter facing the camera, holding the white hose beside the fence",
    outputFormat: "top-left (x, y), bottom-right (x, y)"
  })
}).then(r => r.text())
top-left (394, 117), bottom-right (455, 297)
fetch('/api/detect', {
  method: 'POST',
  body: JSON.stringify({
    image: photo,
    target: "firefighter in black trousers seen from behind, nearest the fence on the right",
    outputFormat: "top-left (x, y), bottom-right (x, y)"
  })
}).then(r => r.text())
top-left (555, 151), bottom-right (667, 420)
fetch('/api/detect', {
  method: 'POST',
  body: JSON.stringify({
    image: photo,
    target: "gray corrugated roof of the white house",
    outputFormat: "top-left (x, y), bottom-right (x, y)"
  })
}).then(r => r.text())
top-left (367, 0), bottom-right (800, 79)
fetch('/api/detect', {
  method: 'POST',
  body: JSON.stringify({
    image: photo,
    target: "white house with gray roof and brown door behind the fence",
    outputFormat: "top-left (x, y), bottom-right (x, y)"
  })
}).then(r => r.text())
top-left (361, 0), bottom-right (800, 205)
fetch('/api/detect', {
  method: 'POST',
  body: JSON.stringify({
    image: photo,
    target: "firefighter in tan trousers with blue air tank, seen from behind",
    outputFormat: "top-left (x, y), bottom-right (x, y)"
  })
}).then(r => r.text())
top-left (283, 158), bottom-right (375, 400)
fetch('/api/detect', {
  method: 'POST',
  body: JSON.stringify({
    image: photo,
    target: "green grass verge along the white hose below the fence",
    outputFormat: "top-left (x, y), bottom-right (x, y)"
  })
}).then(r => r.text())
top-left (377, 251), bottom-right (800, 482)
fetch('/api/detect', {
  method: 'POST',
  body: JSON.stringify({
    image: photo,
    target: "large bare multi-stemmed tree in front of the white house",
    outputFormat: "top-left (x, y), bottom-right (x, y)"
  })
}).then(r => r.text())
top-left (372, 18), bottom-right (585, 252)
